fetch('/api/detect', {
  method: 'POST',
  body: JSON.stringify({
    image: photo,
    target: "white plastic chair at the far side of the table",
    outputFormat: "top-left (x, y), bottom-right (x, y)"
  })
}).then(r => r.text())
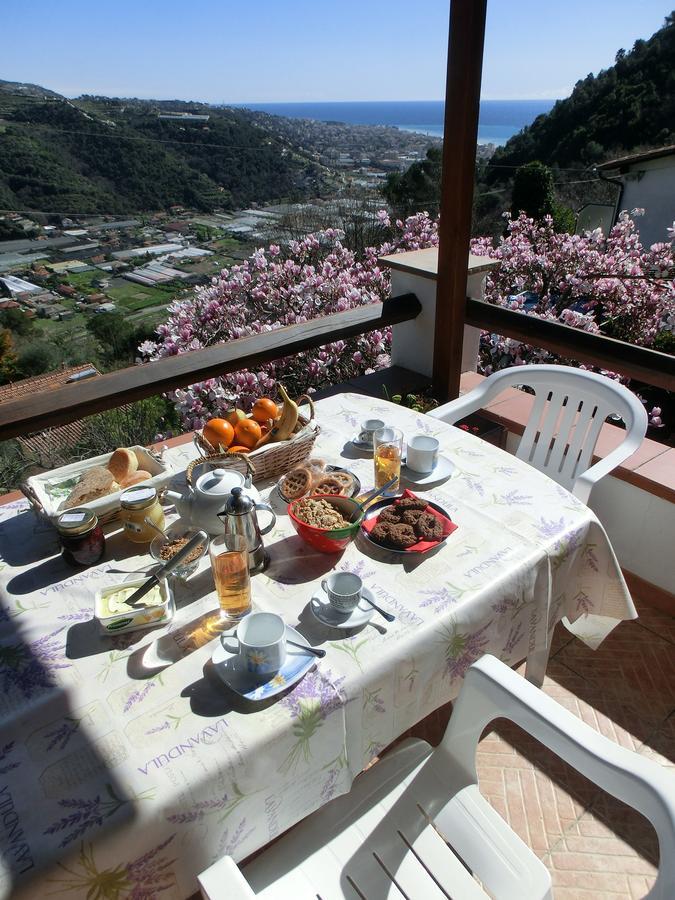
top-left (429, 365), bottom-right (647, 503)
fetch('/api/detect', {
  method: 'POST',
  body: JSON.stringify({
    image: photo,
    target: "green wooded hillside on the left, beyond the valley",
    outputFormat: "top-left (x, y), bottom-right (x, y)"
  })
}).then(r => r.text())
top-left (0, 81), bottom-right (325, 213)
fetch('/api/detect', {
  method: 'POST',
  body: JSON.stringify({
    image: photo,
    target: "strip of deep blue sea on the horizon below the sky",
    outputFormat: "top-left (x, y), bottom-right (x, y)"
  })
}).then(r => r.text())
top-left (237, 100), bottom-right (555, 146)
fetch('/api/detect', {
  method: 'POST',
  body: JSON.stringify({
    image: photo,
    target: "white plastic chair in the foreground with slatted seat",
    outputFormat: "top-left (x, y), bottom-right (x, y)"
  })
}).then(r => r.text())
top-left (199, 656), bottom-right (675, 900)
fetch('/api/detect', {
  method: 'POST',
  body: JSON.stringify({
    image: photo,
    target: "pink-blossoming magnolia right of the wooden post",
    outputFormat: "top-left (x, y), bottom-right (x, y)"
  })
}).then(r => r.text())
top-left (471, 209), bottom-right (675, 428)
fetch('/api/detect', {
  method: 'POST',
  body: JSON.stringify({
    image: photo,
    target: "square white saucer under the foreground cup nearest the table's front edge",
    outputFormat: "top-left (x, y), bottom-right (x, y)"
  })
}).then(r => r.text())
top-left (211, 625), bottom-right (317, 700)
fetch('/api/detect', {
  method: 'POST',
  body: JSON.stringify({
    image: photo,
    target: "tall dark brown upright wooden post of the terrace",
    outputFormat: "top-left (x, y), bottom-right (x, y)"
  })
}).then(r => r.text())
top-left (433, 0), bottom-right (487, 401)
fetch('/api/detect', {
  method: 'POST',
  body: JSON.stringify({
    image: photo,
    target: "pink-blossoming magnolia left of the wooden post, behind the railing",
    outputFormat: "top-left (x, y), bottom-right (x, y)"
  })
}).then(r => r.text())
top-left (139, 212), bottom-right (438, 429)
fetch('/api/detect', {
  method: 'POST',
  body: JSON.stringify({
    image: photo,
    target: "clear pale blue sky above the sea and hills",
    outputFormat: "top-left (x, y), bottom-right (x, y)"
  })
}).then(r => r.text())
top-left (0, 0), bottom-right (672, 102)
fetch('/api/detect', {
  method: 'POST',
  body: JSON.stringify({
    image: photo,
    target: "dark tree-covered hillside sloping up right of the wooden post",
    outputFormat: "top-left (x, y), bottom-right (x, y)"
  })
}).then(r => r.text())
top-left (486, 13), bottom-right (675, 184)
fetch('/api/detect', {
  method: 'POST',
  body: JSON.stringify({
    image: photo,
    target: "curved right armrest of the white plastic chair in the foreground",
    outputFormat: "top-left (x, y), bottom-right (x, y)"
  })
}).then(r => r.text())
top-left (433, 654), bottom-right (675, 900)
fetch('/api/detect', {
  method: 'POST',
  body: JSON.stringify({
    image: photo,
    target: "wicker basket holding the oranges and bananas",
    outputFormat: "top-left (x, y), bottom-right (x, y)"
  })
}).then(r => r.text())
top-left (187, 394), bottom-right (321, 481)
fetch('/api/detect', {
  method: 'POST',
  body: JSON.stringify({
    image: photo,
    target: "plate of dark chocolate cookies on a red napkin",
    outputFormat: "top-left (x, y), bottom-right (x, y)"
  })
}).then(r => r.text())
top-left (361, 491), bottom-right (457, 553)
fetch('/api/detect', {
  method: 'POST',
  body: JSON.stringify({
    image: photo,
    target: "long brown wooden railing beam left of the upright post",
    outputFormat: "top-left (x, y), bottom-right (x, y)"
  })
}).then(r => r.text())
top-left (0, 294), bottom-right (422, 440)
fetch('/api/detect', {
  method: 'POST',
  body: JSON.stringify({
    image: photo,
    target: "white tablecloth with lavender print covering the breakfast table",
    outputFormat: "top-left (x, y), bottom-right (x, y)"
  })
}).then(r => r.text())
top-left (0, 394), bottom-right (635, 900)
